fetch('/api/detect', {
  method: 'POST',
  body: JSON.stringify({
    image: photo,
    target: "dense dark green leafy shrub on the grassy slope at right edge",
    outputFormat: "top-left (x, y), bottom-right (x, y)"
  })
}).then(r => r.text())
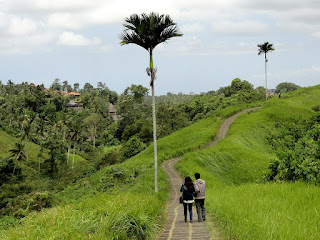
top-left (265, 114), bottom-right (320, 184)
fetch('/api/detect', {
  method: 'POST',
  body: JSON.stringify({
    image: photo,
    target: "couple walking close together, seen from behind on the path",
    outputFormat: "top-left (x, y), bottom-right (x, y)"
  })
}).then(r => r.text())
top-left (180, 173), bottom-right (206, 222)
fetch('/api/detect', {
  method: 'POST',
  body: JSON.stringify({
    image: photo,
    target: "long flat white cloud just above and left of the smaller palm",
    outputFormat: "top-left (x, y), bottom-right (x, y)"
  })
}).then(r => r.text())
top-left (212, 20), bottom-right (270, 36)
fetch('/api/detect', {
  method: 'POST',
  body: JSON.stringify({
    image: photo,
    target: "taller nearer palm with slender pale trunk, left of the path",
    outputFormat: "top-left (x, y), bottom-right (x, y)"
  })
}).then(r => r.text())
top-left (119, 12), bottom-right (183, 192)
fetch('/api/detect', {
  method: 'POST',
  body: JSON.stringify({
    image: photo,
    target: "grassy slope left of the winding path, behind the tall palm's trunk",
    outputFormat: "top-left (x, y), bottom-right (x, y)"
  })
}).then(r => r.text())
top-left (0, 102), bottom-right (260, 239)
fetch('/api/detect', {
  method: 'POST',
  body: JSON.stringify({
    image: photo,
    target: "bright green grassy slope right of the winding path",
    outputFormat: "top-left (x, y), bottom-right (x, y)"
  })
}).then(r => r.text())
top-left (177, 86), bottom-right (320, 239)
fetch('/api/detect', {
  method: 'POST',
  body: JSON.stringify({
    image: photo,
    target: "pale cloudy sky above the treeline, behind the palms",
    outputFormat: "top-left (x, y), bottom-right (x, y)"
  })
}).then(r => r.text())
top-left (0, 0), bottom-right (320, 95)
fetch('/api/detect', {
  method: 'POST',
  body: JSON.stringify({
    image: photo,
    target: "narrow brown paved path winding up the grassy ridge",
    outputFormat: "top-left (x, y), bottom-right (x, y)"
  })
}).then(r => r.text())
top-left (158, 107), bottom-right (259, 240)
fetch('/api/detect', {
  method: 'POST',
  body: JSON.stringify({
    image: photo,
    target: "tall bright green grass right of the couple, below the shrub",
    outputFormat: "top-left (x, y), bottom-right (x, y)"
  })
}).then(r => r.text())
top-left (211, 183), bottom-right (320, 240)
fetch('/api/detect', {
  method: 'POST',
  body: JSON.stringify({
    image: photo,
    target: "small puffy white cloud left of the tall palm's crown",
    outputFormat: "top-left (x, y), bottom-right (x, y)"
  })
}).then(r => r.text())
top-left (57, 32), bottom-right (101, 46)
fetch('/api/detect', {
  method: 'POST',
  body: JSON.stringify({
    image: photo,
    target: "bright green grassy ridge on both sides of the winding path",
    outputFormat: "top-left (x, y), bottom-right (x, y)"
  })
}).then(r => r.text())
top-left (0, 86), bottom-right (320, 239)
